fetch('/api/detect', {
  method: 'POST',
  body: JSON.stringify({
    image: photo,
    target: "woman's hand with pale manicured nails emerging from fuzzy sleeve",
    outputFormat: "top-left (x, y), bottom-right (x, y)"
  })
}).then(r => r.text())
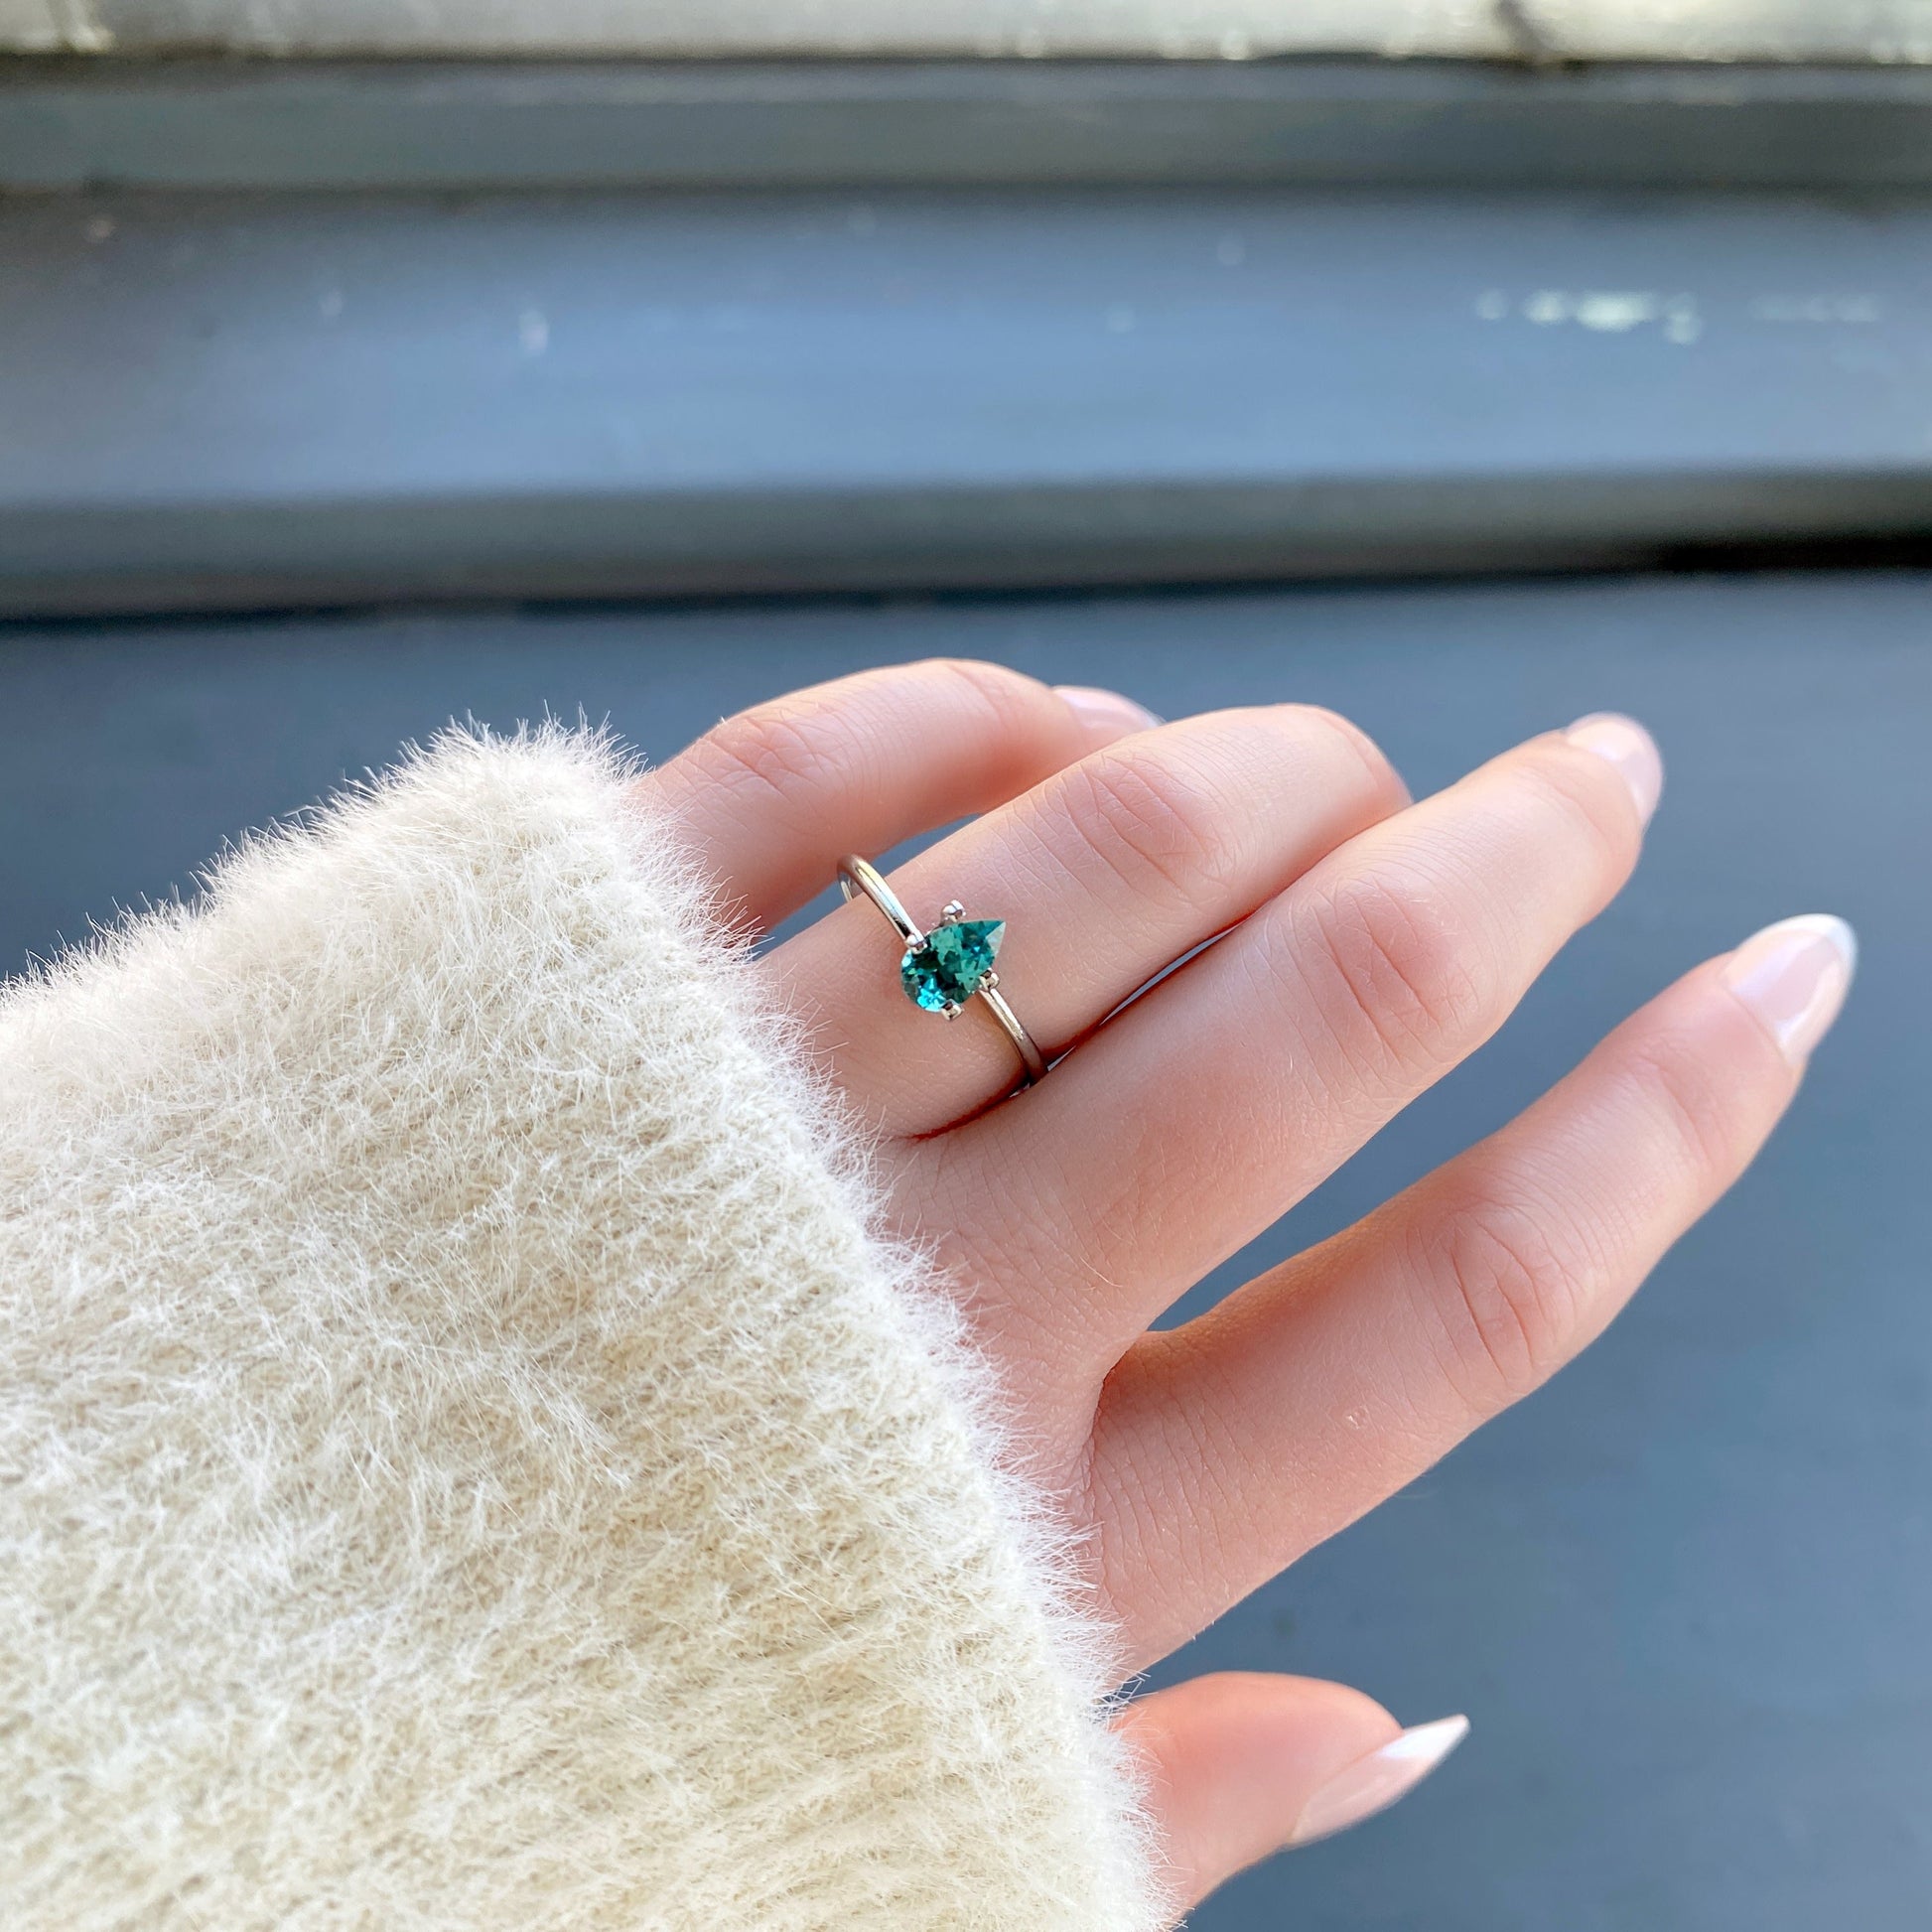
top-left (643, 662), bottom-right (1853, 1903)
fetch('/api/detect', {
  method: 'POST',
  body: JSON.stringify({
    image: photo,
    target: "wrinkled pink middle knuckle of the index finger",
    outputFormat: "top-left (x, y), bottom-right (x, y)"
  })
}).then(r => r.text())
top-left (1418, 1196), bottom-right (1579, 1414)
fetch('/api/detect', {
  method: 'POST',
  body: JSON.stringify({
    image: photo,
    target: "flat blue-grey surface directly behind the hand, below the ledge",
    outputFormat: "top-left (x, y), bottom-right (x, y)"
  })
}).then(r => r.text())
top-left (0, 576), bottom-right (1932, 1932)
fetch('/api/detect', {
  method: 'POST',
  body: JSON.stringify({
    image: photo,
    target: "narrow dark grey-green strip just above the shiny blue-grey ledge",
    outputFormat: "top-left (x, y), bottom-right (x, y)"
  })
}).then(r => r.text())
top-left (11, 58), bottom-right (1932, 194)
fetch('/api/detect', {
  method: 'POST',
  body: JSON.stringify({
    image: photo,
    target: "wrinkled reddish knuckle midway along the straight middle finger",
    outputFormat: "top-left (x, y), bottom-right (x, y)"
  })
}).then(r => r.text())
top-left (1317, 877), bottom-right (1489, 1076)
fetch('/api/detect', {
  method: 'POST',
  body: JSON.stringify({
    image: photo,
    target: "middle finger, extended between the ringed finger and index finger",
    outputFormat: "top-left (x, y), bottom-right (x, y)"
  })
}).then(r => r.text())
top-left (919, 719), bottom-right (1662, 1379)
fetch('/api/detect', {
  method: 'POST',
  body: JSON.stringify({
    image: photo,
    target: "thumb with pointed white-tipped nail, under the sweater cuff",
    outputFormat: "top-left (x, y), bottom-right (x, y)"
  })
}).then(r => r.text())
top-left (1119, 1671), bottom-right (1468, 1914)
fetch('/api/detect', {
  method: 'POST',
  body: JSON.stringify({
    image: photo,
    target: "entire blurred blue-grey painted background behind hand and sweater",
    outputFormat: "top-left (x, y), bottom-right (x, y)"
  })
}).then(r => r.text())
top-left (0, 0), bottom-right (1932, 1932)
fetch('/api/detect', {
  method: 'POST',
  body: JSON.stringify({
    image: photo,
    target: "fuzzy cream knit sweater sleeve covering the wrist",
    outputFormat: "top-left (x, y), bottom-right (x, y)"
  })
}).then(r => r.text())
top-left (0, 733), bottom-right (1163, 1932)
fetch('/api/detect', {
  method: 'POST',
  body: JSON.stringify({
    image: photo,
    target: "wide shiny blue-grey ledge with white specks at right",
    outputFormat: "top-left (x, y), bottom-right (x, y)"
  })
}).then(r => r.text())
top-left (11, 188), bottom-right (1932, 615)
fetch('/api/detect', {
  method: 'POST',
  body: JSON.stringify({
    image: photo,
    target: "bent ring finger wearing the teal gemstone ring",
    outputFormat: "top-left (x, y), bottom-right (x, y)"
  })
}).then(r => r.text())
top-left (769, 705), bottom-right (1407, 1136)
